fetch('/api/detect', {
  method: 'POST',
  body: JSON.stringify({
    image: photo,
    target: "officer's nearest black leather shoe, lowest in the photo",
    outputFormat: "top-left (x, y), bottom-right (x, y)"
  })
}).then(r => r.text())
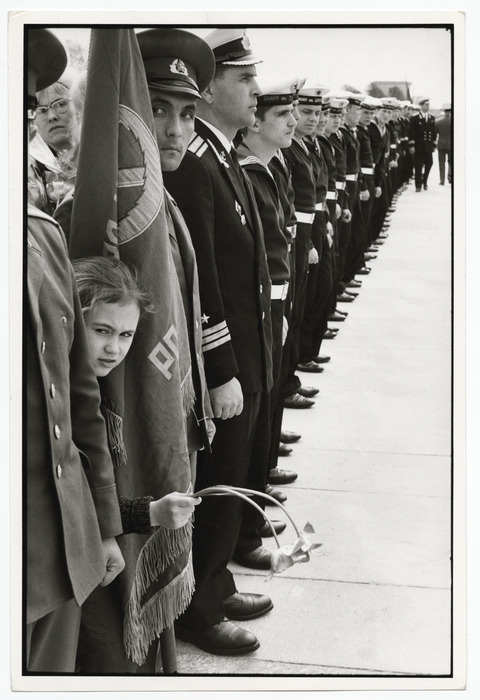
top-left (175, 620), bottom-right (260, 656)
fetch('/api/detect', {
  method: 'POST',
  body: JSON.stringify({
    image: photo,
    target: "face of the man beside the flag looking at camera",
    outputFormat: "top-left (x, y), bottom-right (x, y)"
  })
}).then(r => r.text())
top-left (149, 88), bottom-right (197, 172)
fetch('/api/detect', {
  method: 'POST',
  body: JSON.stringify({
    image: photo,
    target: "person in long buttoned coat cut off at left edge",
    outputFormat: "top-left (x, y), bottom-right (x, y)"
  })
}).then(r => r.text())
top-left (23, 29), bottom-right (124, 673)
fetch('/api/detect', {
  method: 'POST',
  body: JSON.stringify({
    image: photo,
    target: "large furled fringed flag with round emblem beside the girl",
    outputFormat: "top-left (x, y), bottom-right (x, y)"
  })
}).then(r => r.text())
top-left (69, 28), bottom-right (195, 663)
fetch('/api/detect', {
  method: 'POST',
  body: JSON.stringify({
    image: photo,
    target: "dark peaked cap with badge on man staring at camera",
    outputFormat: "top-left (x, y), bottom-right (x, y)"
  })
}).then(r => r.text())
top-left (137, 28), bottom-right (215, 97)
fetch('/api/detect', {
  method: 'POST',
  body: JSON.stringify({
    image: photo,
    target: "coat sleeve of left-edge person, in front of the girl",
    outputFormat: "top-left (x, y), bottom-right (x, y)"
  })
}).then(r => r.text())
top-left (68, 263), bottom-right (122, 538)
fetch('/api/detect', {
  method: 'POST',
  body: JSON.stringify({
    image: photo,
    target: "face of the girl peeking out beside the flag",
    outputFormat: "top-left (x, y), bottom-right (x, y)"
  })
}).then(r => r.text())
top-left (85, 301), bottom-right (140, 377)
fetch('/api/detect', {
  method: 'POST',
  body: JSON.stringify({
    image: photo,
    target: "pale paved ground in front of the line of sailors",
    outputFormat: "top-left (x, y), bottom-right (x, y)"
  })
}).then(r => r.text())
top-left (173, 172), bottom-right (451, 689)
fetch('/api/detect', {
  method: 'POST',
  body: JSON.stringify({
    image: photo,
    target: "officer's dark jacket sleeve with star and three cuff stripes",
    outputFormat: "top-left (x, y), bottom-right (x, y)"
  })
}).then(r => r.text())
top-left (164, 152), bottom-right (239, 389)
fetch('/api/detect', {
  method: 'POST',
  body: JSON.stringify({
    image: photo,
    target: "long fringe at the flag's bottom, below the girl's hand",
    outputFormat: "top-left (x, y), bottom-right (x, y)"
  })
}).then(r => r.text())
top-left (123, 521), bottom-right (195, 664)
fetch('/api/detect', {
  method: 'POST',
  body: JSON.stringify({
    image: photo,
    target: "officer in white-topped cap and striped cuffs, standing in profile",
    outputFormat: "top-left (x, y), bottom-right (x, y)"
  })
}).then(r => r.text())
top-left (165, 29), bottom-right (273, 655)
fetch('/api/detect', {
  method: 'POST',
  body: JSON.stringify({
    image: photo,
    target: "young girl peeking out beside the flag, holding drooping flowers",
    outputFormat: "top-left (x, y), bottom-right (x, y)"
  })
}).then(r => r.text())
top-left (73, 257), bottom-right (201, 673)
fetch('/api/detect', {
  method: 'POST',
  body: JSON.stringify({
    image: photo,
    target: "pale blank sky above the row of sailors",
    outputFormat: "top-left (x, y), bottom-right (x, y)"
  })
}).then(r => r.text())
top-left (50, 23), bottom-right (451, 108)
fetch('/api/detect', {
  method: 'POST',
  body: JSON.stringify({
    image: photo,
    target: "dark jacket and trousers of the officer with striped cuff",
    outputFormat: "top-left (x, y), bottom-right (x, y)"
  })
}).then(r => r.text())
top-left (165, 119), bottom-right (272, 627)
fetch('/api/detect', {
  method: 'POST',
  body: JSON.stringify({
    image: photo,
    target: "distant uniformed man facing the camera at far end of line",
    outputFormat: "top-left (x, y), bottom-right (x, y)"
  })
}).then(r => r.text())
top-left (409, 97), bottom-right (437, 192)
